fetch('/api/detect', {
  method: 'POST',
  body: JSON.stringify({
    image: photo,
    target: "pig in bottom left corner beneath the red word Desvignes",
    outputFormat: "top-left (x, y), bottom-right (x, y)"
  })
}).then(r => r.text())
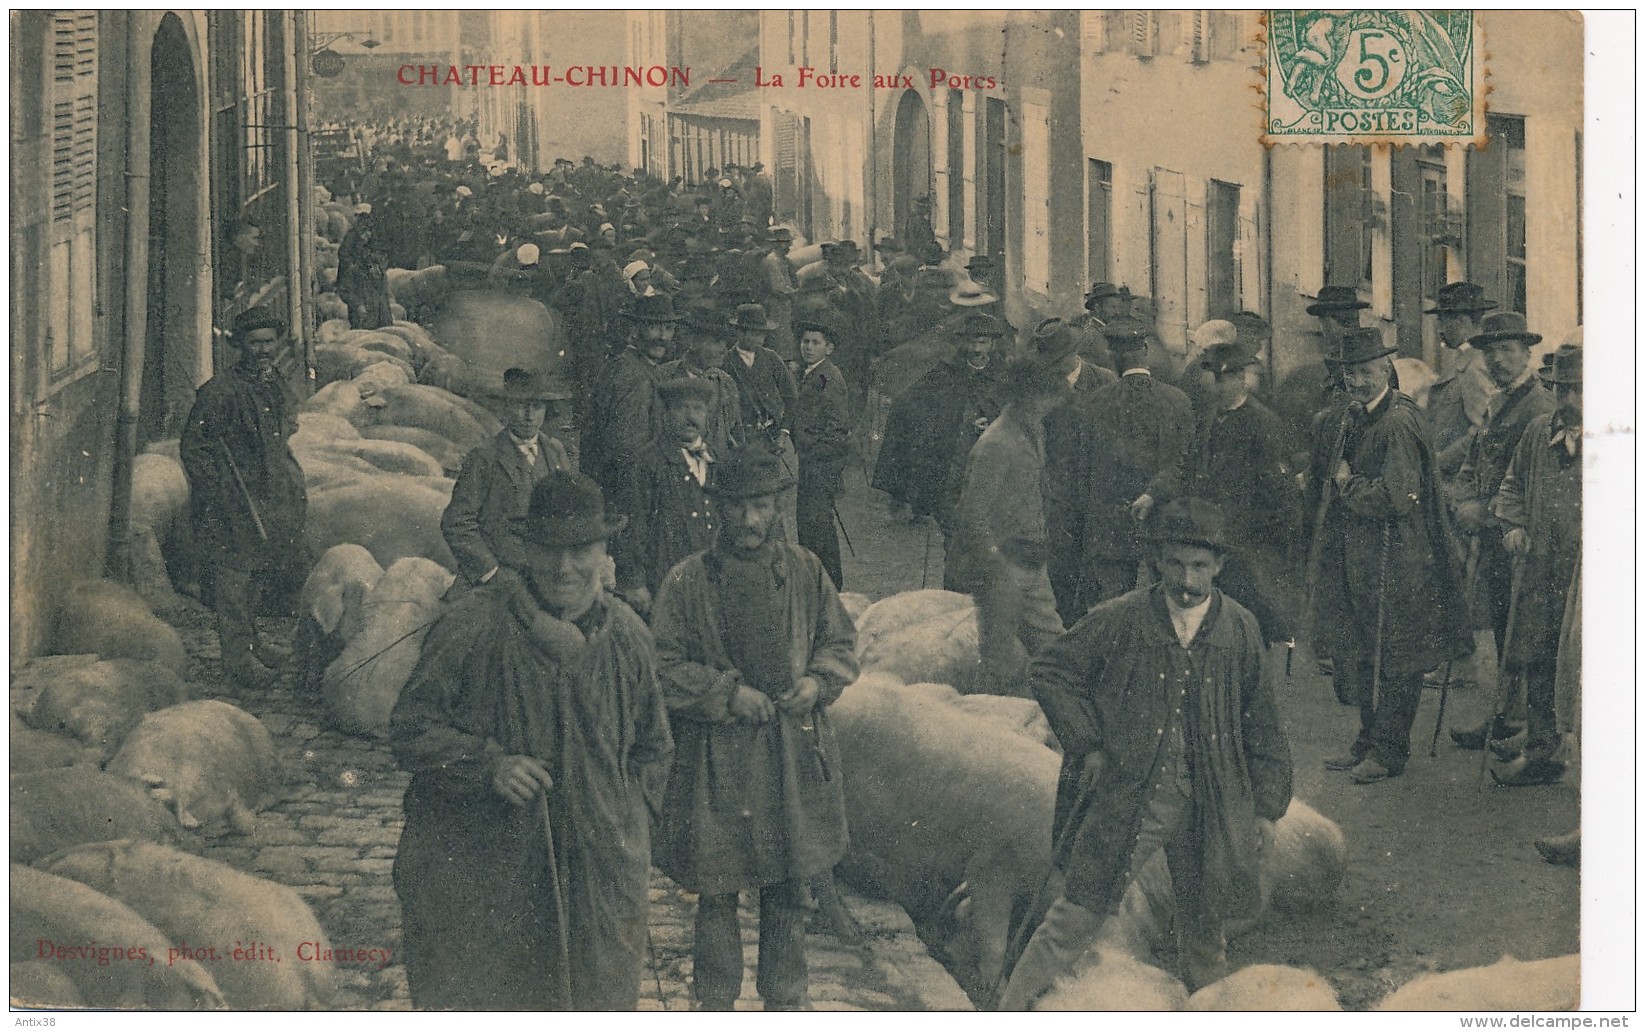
top-left (10, 863), bottom-right (225, 1010)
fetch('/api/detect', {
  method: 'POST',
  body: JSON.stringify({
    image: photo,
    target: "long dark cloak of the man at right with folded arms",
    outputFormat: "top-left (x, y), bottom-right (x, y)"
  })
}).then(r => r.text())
top-left (1314, 390), bottom-right (1473, 676)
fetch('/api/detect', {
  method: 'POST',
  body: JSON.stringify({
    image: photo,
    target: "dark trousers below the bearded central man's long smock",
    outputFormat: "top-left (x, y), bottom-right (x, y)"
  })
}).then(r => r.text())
top-left (691, 881), bottom-right (809, 1010)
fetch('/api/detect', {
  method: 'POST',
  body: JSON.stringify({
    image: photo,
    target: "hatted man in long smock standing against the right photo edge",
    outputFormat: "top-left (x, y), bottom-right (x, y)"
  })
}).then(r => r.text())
top-left (1492, 347), bottom-right (1582, 788)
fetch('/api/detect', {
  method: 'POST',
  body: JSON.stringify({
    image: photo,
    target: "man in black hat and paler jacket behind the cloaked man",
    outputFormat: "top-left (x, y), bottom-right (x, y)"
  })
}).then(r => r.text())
top-left (1423, 283), bottom-right (1512, 485)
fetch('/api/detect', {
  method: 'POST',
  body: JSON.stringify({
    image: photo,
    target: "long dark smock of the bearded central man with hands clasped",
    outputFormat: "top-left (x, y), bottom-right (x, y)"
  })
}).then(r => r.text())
top-left (651, 543), bottom-right (857, 895)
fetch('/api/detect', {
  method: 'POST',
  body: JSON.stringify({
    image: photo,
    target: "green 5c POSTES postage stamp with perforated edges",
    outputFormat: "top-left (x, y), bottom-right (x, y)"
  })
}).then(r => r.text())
top-left (1263, 10), bottom-right (1485, 145)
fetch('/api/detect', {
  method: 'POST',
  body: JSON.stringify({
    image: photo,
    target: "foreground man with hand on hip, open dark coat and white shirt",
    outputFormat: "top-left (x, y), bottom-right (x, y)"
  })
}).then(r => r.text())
top-left (999, 498), bottom-right (1291, 1010)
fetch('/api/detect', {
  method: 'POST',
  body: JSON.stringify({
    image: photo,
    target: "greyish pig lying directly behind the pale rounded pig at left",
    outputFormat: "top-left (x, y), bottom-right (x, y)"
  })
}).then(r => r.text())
top-left (28, 659), bottom-right (188, 755)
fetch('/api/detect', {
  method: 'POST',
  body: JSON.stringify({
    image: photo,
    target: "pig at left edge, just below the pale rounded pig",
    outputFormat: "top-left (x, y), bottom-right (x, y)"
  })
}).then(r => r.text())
top-left (12, 766), bottom-right (181, 863)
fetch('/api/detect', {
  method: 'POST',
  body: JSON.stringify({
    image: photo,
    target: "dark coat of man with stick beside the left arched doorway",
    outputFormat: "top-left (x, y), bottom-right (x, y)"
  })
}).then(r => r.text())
top-left (178, 365), bottom-right (311, 612)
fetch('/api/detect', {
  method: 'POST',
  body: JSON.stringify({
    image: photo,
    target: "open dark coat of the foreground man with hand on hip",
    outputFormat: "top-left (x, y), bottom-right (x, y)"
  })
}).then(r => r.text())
top-left (1028, 585), bottom-right (1291, 919)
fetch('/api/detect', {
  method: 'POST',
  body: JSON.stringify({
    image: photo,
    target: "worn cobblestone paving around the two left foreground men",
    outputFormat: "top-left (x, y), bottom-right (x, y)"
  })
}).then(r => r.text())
top-left (171, 605), bottom-right (972, 1011)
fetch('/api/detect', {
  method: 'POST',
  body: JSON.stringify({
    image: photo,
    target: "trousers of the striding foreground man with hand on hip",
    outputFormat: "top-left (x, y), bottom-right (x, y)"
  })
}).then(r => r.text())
top-left (999, 784), bottom-right (1227, 1011)
